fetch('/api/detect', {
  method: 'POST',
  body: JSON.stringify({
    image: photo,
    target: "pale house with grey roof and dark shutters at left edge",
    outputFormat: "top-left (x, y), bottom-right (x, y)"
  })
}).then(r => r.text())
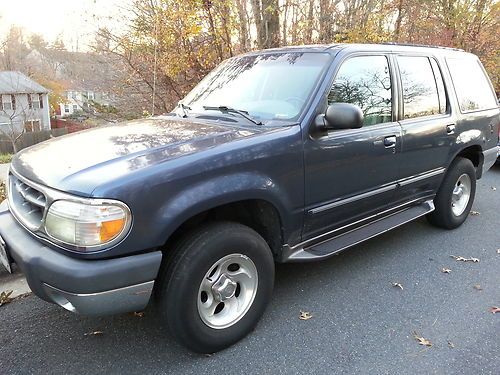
top-left (0, 72), bottom-right (50, 136)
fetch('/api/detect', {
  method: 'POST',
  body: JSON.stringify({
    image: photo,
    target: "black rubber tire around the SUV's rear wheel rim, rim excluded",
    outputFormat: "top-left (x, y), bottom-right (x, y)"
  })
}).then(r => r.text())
top-left (427, 157), bottom-right (476, 229)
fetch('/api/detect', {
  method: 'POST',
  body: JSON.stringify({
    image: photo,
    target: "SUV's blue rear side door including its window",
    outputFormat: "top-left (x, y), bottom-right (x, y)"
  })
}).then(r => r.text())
top-left (392, 55), bottom-right (456, 205)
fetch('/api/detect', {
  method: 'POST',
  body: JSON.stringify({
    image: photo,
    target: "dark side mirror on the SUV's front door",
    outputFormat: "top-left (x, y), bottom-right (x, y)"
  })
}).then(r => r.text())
top-left (322, 103), bottom-right (363, 130)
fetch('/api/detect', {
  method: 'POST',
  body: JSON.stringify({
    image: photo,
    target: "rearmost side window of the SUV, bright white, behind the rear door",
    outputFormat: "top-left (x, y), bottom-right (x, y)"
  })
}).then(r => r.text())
top-left (446, 58), bottom-right (498, 112)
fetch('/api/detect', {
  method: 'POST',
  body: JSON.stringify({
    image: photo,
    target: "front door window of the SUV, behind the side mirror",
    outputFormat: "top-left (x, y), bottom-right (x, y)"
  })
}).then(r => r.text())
top-left (328, 56), bottom-right (392, 126)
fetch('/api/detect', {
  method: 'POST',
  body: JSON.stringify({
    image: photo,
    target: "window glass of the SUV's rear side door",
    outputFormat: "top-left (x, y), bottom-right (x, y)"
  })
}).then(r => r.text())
top-left (397, 56), bottom-right (446, 119)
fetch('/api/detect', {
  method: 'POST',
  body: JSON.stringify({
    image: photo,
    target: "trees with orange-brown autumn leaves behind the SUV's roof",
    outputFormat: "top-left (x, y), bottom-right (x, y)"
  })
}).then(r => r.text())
top-left (94, 0), bottom-right (500, 116)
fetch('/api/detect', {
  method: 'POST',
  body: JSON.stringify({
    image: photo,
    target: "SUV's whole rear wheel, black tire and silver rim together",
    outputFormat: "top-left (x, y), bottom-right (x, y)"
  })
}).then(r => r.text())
top-left (427, 157), bottom-right (476, 229)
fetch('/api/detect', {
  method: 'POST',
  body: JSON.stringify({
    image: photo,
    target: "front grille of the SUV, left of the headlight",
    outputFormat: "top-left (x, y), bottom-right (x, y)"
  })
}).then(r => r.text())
top-left (9, 174), bottom-right (47, 230)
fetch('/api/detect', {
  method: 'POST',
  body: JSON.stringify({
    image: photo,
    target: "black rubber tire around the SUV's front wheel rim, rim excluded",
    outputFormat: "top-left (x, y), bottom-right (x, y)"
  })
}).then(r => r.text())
top-left (157, 222), bottom-right (274, 354)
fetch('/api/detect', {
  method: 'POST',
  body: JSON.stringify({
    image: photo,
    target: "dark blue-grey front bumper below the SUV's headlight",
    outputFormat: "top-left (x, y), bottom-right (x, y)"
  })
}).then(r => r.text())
top-left (0, 202), bottom-right (162, 315)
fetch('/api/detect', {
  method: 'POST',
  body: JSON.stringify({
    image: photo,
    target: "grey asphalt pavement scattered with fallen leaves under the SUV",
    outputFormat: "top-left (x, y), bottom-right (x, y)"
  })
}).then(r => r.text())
top-left (0, 167), bottom-right (500, 374)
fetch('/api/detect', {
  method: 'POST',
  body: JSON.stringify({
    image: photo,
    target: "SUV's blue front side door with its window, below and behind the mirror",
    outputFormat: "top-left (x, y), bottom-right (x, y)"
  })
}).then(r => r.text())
top-left (303, 53), bottom-right (401, 240)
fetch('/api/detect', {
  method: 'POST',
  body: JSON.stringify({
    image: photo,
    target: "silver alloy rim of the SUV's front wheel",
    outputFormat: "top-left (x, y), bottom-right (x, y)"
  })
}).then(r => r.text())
top-left (197, 253), bottom-right (258, 329)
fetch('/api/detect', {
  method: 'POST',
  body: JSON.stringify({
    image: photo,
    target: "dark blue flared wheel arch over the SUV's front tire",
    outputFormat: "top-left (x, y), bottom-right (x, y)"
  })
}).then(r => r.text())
top-left (155, 172), bottom-right (296, 255)
